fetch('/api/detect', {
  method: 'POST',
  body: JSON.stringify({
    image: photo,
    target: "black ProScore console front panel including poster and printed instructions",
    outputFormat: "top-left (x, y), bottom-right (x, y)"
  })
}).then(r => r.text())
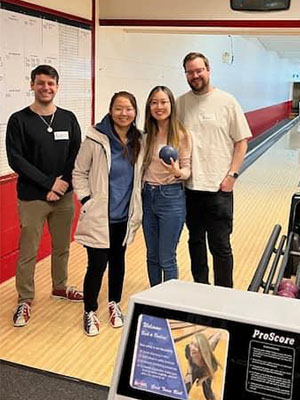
top-left (123, 305), bottom-right (300, 400)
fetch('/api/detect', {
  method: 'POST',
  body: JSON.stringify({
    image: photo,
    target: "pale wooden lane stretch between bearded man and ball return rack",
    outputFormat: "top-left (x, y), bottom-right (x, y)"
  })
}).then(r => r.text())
top-left (232, 122), bottom-right (300, 289)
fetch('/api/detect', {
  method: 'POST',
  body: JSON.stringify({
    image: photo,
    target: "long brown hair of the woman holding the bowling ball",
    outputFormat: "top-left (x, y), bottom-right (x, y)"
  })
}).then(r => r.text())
top-left (144, 86), bottom-right (188, 169)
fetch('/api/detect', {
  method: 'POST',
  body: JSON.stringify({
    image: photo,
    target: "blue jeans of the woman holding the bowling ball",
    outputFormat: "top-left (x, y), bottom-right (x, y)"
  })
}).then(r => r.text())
top-left (142, 183), bottom-right (186, 286)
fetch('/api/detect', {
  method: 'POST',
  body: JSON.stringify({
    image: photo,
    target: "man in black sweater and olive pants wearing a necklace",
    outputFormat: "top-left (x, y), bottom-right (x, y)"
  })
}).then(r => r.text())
top-left (6, 65), bottom-right (83, 327)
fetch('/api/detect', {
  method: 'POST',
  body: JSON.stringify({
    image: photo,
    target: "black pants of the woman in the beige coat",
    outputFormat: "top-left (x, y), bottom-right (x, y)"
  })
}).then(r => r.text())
top-left (83, 222), bottom-right (127, 312)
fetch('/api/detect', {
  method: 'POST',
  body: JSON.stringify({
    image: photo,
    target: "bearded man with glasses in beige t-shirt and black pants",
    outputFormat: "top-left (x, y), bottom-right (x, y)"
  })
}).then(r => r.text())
top-left (177, 53), bottom-right (251, 287)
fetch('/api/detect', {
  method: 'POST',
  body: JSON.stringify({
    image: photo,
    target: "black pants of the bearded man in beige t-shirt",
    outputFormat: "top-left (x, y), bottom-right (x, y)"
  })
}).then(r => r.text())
top-left (186, 189), bottom-right (233, 287)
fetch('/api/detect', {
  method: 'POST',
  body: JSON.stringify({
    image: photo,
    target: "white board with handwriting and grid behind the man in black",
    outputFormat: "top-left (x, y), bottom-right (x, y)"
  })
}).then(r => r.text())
top-left (0, 2), bottom-right (92, 176)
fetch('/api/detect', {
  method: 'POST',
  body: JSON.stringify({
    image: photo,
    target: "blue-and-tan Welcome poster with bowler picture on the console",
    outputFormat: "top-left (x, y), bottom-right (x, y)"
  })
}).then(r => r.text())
top-left (130, 314), bottom-right (229, 400)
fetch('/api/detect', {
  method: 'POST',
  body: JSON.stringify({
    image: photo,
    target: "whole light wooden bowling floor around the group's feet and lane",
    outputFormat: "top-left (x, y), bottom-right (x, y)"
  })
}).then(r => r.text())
top-left (0, 123), bottom-right (300, 386)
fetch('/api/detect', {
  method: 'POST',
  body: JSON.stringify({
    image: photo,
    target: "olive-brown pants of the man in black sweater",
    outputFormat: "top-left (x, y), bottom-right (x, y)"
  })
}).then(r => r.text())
top-left (16, 192), bottom-right (74, 303)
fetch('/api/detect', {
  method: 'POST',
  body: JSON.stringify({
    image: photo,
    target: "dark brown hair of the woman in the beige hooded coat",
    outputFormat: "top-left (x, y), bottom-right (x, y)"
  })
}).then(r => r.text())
top-left (109, 90), bottom-right (141, 164)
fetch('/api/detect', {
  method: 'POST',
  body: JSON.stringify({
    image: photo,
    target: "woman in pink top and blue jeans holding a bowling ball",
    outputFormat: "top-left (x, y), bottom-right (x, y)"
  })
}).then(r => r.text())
top-left (142, 86), bottom-right (191, 286)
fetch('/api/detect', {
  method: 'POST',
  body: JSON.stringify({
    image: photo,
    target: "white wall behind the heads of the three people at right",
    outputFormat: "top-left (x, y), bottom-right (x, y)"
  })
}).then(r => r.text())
top-left (95, 28), bottom-right (295, 126)
